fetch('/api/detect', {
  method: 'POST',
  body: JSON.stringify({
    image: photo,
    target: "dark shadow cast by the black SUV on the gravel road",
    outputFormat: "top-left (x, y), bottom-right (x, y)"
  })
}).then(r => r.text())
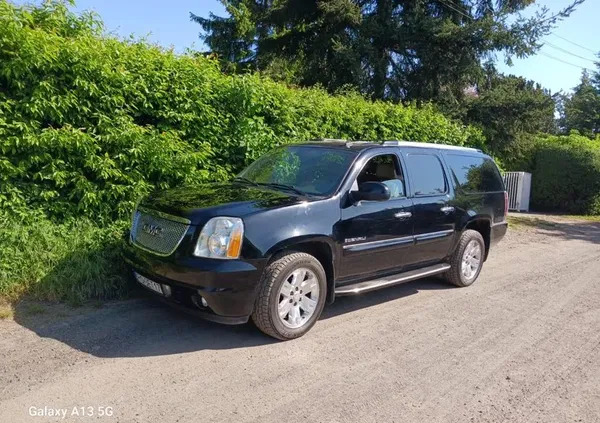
top-left (14, 278), bottom-right (451, 358)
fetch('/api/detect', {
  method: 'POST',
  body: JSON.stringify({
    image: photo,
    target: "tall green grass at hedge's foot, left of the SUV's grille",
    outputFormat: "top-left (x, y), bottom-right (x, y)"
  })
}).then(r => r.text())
top-left (0, 214), bottom-right (130, 304)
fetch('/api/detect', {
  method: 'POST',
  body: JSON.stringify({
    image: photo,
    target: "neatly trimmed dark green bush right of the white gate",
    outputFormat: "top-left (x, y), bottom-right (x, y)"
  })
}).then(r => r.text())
top-left (531, 133), bottom-right (600, 215)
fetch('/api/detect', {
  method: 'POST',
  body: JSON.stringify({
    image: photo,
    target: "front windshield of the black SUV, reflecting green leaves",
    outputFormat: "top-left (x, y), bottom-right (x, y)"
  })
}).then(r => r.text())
top-left (238, 146), bottom-right (356, 195)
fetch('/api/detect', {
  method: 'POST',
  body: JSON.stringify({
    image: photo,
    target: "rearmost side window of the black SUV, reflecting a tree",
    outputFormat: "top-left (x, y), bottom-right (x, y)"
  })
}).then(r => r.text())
top-left (446, 154), bottom-right (504, 192)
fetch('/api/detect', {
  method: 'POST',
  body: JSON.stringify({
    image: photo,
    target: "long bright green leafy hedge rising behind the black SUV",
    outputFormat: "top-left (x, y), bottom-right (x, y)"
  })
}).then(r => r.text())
top-left (0, 0), bottom-right (483, 225)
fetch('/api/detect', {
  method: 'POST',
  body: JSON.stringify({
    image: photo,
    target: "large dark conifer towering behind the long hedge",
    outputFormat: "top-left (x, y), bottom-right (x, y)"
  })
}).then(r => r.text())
top-left (191, 0), bottom-right (584, 104)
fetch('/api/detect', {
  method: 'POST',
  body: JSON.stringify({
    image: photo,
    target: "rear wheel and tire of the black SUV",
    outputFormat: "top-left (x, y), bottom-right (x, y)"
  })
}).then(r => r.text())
top-left (444, 229), bottom-right (485, 287)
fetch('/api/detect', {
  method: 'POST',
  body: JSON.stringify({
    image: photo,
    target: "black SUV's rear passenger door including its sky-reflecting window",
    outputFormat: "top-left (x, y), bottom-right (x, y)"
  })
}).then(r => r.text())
top-left (403, 149), bottom-right (456, 265)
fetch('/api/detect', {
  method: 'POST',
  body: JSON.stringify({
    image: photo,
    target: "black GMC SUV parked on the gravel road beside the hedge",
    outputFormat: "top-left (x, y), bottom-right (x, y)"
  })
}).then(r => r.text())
top-left (125, 141), bottom-right (508, 339)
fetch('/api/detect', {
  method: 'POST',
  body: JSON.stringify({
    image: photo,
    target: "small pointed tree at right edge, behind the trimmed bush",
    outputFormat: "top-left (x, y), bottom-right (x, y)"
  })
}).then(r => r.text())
top-left (563, 70), bottom-right (600, 138)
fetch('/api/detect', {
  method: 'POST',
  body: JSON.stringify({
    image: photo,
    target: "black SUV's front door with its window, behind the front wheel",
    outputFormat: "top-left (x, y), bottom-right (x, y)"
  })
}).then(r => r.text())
top-left (336, 149), bottom-right (413, 279)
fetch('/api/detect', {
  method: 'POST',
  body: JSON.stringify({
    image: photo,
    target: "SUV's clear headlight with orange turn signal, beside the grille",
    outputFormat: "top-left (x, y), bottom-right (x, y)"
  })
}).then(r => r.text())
top-left (194, 217), bottom-right (244, 259)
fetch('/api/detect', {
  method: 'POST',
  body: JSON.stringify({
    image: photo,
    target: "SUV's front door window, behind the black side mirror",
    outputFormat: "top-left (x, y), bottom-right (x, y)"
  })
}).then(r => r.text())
top-left (353, 154), bottom-right (406, 199)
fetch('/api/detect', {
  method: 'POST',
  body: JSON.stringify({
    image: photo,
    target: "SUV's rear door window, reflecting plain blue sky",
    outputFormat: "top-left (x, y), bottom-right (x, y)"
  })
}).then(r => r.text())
top-left (406, 154), bottom-right (446, 196)
